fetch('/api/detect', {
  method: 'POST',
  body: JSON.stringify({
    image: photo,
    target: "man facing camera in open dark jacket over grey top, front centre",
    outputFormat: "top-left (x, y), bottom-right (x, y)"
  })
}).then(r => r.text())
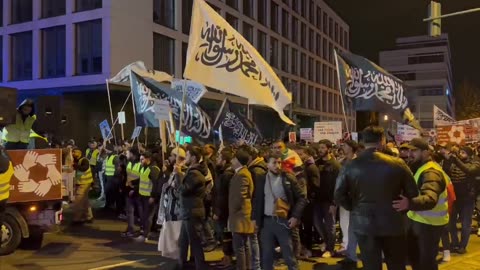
top-left (252, 154), bottom-right (307, 270)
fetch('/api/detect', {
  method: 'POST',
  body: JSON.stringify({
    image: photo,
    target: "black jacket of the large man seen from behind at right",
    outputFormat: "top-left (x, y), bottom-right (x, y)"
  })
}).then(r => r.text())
top-left (336, 148), bottom-right (418, 236)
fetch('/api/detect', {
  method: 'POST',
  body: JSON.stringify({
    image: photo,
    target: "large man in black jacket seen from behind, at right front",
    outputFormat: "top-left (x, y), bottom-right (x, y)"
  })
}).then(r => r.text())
top-left (336, 127), bottom-right (418, 270)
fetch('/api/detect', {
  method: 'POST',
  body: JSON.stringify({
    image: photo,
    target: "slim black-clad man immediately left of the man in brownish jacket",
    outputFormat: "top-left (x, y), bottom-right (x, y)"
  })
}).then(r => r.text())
top-left (213, 148), bottom-right (235, 268)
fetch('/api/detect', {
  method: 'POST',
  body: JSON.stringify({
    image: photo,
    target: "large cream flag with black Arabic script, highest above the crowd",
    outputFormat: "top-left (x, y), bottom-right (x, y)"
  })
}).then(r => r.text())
top-left (183, 0), bottom-right (294, 125)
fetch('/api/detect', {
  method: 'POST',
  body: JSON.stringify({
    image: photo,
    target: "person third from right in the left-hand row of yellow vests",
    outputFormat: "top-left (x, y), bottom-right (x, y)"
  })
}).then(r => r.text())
top-left (104, 144), bottom-right (120, 212)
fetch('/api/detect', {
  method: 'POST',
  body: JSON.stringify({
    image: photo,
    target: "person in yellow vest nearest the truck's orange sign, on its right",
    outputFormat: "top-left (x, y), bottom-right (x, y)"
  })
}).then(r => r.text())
top-left (72, 148), bottom-right (93, 224)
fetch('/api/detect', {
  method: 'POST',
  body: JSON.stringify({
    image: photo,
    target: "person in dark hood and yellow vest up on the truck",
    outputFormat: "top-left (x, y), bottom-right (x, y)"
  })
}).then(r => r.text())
top-left (3, 99), bottom-right (37, 150)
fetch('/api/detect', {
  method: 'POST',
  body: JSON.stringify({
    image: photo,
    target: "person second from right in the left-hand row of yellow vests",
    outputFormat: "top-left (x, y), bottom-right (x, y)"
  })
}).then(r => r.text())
top-left (121, 148), bottom-right (142, 237)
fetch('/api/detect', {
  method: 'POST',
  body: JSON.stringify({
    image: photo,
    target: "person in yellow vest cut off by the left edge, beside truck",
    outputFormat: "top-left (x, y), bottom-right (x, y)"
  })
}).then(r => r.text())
top-left (0, 149), bottom-right (14, 232)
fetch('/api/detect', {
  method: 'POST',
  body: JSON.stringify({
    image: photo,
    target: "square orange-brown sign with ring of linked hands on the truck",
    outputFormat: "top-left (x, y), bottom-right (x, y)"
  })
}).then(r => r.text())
top-left (7, 149), bottom-right (62, 203)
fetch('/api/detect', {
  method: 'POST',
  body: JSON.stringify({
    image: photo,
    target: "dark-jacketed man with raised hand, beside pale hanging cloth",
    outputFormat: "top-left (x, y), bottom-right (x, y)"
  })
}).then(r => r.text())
top-left (174, 146), bottom-right (208, 270)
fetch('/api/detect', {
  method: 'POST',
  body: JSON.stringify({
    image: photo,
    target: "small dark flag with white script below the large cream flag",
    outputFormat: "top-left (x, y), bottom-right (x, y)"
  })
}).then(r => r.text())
top-left (214, 98), bottom-right (262, 145)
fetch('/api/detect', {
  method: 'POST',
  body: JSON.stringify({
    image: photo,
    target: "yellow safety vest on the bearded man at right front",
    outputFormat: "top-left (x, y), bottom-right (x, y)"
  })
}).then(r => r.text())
top-left (407, 161), bottom-right (450, 226)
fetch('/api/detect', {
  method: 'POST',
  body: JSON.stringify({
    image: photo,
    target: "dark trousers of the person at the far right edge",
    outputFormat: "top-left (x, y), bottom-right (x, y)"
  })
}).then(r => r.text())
top-left (448, 199), bottom-right (475, 248)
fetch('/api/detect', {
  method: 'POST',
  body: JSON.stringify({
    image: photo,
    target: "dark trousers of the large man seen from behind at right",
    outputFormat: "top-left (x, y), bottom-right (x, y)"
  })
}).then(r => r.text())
top-left (355, 233), bottom-right (406, 270)
